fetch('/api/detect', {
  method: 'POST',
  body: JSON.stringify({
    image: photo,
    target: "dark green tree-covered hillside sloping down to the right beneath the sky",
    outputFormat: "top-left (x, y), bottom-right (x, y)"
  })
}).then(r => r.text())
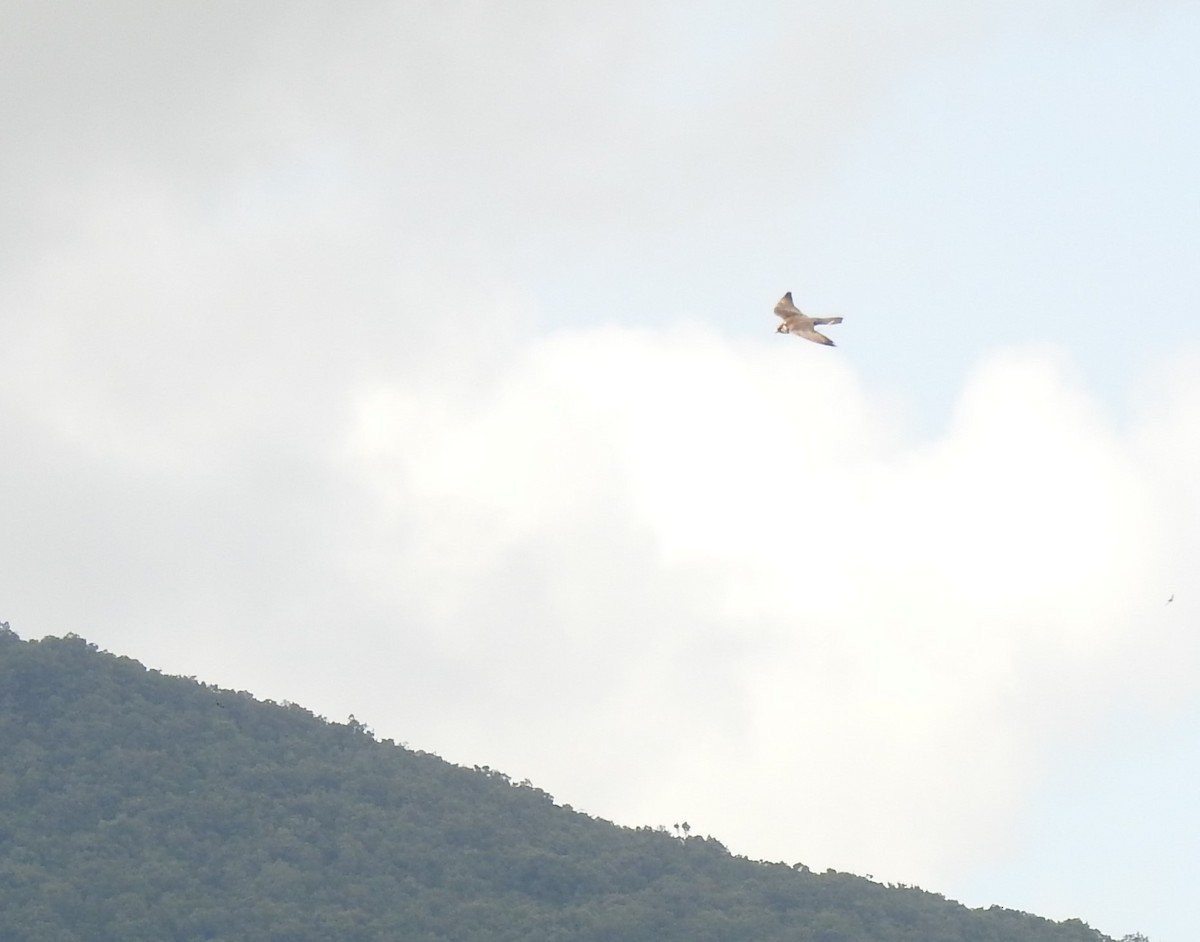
top-left (0, 626), bottom-right (1104, 942)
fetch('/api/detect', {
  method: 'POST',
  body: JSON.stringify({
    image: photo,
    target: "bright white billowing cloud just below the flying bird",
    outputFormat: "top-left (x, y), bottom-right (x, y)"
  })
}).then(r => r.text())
top-left (343, 329), bottom-right (1195, 880)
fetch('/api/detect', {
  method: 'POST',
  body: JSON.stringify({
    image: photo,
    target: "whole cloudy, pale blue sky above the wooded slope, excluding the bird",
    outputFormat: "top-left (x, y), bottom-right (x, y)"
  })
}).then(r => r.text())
top-left (0, 0), bottom-right (1200, 942)
